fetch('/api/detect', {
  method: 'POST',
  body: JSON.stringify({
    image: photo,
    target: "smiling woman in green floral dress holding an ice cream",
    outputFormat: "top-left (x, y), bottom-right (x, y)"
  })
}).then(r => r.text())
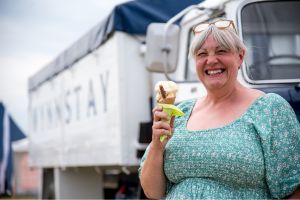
top-left (140, 20), bottom-right (300, 199)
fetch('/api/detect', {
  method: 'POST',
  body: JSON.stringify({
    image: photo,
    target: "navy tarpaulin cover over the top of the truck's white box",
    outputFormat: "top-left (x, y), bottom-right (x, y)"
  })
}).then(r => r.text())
top-left (29, 0), bottom-right (202, 90)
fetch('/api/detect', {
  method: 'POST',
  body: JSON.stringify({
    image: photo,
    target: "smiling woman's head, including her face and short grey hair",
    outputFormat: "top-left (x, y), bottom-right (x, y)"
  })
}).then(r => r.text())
top-left (191, 26), bottom-right (245, 90)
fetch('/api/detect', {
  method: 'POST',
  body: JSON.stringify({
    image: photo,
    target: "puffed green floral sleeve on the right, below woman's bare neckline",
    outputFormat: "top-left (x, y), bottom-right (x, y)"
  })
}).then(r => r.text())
top-left (257, 94), bottom-right (300, 198)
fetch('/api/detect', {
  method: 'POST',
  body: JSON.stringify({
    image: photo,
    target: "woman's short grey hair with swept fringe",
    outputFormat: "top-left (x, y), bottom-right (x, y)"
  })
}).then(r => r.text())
top-left (189, 25), bottom-right (246, 58)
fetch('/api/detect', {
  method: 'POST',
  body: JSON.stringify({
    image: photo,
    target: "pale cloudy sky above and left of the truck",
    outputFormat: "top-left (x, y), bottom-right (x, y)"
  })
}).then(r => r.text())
top-left (0, 0), bottom-right (127, 134)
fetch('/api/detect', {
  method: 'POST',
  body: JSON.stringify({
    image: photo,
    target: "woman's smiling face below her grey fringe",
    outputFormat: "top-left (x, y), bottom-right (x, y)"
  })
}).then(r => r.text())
top-left (196, 34), bottom-right (245, 90)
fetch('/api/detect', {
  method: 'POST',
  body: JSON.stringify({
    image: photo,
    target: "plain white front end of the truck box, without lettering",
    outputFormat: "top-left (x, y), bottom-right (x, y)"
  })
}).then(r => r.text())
top-left (118, 34), bottom-right (152, 165)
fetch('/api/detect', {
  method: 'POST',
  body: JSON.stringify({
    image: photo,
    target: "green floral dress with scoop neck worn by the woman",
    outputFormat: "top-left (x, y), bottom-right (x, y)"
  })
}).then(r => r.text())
top-left (141, 94), bottom-right (300, 199)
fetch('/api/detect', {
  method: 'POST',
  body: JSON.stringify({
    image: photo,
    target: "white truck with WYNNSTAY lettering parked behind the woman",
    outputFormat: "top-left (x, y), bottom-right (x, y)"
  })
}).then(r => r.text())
top-left (29, 0), bottom-right (300, 199)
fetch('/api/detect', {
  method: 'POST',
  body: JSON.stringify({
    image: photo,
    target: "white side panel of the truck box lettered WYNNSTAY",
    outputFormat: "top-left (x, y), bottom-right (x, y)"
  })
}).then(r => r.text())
top-left (29, 34), bottom-right (122, 166)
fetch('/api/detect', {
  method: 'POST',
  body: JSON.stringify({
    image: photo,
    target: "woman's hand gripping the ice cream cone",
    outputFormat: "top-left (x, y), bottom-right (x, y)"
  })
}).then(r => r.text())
top-left (151, 106), bottom-right (174, 150)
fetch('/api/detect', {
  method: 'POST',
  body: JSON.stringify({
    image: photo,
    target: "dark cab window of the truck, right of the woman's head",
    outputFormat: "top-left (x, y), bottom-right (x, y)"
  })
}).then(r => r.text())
top-left (241, 1), bottom-right (300, 83)
